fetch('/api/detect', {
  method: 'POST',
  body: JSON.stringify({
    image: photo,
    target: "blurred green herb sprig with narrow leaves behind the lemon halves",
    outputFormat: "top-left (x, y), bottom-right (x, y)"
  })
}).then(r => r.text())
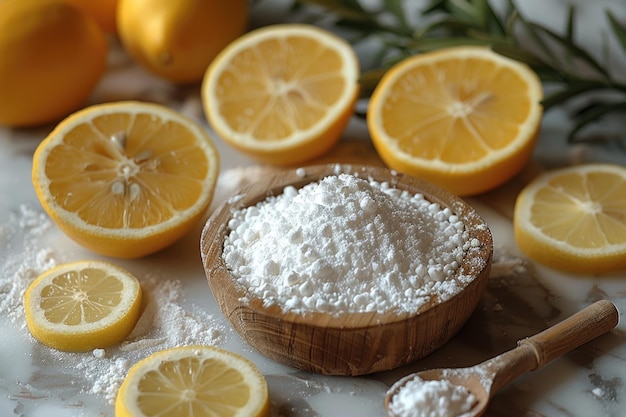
top-left (295, 0), bottom-right (626, 142)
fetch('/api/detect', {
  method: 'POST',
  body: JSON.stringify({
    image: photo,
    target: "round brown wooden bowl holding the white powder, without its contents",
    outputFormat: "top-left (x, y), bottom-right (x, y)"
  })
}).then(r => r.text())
top-left (200, 164), bottom-right (493, 375)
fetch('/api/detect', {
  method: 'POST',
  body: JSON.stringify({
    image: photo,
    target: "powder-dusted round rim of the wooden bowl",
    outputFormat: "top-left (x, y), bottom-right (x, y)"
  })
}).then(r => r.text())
top-left (200, 163), bottom-right (493, 329)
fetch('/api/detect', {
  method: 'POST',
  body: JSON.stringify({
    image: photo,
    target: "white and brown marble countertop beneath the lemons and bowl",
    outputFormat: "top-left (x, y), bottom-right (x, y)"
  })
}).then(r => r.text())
top-left (0, 1), bottom-right (626, 417)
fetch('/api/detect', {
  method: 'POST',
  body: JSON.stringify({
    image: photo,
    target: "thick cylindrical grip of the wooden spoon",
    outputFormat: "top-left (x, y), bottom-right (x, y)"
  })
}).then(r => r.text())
top-left (518, 300), bottom-right (619, 370)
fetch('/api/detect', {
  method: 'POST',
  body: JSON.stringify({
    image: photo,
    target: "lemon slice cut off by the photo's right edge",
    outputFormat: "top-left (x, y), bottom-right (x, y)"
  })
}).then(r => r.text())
top-left (514, 164), bottom-right (626, 273)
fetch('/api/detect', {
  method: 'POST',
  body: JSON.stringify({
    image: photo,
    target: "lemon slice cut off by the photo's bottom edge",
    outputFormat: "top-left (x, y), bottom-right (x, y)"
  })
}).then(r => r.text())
top-left (115, 346), bottom-right (269, 417)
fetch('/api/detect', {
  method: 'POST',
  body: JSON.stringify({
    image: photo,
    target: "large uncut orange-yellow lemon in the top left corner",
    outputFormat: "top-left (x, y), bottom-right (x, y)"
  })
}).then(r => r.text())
top-left (0, 0), bottom-right (108, 127)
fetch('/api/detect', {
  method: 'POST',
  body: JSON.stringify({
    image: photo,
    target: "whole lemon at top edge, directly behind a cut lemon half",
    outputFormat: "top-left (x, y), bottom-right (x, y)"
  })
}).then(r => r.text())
top-left (117, 0), bottom-right (248, 84)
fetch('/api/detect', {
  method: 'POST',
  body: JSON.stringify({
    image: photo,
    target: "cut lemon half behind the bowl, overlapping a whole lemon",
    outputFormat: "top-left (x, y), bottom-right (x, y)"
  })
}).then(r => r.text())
top-left (202, 24), bottom-right (360, 165)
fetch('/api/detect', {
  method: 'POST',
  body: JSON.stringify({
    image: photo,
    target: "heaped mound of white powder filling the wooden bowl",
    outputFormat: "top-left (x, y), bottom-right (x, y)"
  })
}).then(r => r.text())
top-left (223, 174), bottom-right (472, 314)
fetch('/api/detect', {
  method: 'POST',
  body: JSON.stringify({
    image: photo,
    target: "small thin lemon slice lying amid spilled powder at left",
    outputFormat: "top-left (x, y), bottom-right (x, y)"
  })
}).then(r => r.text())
top-left (24, 261), bottom-right (141, 352)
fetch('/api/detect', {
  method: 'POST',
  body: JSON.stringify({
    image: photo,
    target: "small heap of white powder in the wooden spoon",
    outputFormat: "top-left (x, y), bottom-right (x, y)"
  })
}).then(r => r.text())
top-left (389, 377), bottom-right (476, 417)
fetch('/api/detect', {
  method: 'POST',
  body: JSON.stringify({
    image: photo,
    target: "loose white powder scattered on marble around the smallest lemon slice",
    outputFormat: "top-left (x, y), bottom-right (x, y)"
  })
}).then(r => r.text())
top-left (0, 205), bottom-right (226, 403)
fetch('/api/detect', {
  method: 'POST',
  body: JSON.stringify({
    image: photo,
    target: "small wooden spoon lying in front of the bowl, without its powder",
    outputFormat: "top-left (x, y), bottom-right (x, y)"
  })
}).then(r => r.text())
top-left (385, 300), bottom-right (619, 417)
